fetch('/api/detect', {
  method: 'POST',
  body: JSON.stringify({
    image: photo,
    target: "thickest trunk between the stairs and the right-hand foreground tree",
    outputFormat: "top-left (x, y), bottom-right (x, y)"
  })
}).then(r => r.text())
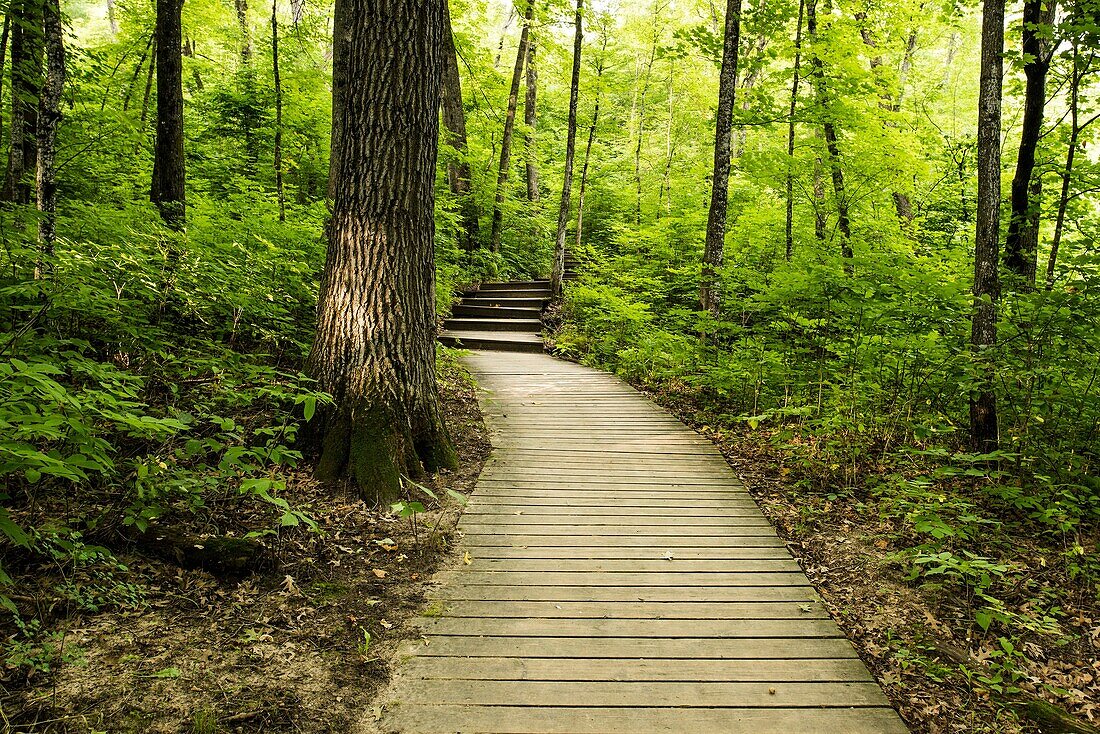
top-left (699, 0), bottom-right (741, 314)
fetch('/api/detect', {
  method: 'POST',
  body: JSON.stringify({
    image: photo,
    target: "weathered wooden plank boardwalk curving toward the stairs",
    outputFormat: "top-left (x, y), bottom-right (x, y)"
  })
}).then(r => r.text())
top-left (381, 352), bottom-right (908, 734)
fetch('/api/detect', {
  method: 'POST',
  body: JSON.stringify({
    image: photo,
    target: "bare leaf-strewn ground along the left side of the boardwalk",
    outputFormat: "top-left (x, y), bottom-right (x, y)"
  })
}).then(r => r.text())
top-left (0, 352), bottom-right (490, 734)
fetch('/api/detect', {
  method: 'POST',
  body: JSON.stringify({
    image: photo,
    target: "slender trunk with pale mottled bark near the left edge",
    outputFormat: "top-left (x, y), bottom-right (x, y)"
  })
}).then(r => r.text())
top-left (35, 0), bottom-right (65, 277)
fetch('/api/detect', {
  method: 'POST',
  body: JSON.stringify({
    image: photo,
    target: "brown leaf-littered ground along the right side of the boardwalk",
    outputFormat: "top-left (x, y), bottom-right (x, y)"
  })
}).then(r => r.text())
top-left (650, 393), bottom-right (1100, 734)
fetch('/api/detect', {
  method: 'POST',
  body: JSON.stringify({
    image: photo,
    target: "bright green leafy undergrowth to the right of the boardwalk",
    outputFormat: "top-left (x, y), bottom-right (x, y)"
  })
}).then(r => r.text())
top-left (554, 239), bottom-right (1100, 730)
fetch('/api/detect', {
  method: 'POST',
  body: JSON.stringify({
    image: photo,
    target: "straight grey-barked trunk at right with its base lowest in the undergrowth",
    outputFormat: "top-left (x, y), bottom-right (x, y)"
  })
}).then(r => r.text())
top-left (970, 0), bottom-right (1004, 452)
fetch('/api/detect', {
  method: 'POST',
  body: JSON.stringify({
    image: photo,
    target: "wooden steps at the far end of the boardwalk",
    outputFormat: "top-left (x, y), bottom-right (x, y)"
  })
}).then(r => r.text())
top-left (439, 281), bottom-right (550, 352)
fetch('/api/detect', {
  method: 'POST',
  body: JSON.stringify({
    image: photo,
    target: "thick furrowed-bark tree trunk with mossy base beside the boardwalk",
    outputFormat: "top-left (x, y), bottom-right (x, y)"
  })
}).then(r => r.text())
top-left (306, 0), bottom-right (455, 502)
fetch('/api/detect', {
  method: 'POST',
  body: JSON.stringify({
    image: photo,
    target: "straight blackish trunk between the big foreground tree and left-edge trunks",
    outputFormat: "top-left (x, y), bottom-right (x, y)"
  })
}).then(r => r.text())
top-left (152, 0), bottom-right (186, 229)
